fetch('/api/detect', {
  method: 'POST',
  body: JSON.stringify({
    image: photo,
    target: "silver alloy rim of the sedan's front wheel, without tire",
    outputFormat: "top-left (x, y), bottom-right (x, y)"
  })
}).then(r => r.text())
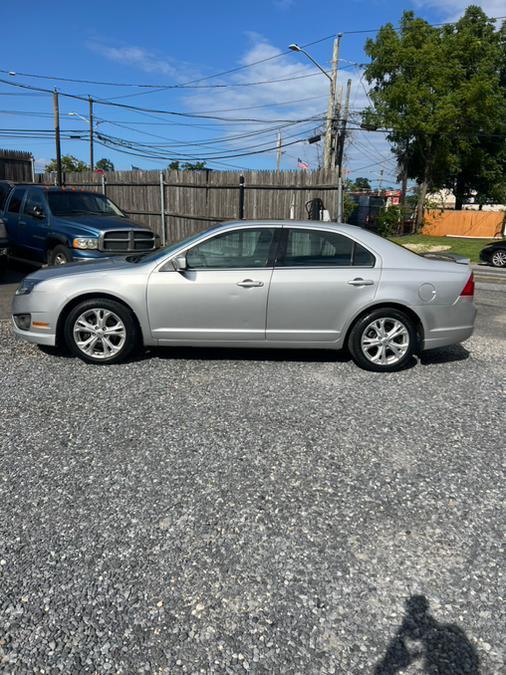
top-left (73, 307), bottom-right (127, 360)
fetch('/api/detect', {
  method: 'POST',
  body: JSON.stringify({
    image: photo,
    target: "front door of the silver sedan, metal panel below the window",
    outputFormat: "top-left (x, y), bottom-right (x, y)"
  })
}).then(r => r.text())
top-left (147, 269), bottom-right (272, 343)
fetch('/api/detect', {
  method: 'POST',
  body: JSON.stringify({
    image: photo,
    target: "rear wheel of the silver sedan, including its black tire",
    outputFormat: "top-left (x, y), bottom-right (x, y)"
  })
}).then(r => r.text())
top-left (348, 307), bottom-right (418, 373)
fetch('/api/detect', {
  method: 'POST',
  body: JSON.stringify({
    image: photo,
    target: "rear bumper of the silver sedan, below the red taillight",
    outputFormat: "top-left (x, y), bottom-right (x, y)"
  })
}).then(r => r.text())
top-left (422, 297), bottom-right (476, 350)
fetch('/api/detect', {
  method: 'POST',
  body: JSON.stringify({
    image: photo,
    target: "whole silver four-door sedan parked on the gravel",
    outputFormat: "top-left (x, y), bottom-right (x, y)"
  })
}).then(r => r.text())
top-left (12, 221), bottom-right (476, 371)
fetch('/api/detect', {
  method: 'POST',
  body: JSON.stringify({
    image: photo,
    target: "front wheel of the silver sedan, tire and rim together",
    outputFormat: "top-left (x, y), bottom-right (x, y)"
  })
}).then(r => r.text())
top-left (64, 298), bottom-right (138, 364)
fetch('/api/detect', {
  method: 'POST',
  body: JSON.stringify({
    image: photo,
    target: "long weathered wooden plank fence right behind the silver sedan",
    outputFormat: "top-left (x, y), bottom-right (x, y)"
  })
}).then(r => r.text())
top-left (38, 169), bottom-right (337, 241)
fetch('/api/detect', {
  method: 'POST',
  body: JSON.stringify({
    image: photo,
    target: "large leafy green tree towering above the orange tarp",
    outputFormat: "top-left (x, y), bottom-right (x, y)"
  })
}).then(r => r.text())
top-left (363, 6), bottom-right (506, 225)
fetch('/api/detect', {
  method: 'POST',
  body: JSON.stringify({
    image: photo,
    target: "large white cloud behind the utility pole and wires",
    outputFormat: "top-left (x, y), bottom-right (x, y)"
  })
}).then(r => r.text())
top-left (184, 34), bottom-right (391, 177)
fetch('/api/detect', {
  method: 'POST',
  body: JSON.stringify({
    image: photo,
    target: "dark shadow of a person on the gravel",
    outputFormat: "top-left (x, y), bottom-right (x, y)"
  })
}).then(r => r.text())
top-left (374, 595), bottom-right (480, 675)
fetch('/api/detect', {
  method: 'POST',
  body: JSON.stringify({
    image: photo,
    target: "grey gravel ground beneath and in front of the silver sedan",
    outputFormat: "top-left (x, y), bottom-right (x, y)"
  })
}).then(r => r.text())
top-left (0, 296), bottom-right (506, 675)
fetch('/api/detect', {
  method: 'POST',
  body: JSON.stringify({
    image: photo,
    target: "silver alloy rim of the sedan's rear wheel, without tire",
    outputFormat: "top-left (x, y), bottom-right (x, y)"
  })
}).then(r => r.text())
top-left (360, 317), bottom-right (410, 366)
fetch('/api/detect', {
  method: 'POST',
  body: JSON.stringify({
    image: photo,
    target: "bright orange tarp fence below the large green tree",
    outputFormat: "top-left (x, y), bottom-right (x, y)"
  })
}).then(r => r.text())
top-left (422, 209), bottom-right (505, 238)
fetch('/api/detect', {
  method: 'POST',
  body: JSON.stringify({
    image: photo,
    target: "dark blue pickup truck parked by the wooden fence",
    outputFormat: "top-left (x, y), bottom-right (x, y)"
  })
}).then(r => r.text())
top-left (0, 184), bottom-right (160, 265)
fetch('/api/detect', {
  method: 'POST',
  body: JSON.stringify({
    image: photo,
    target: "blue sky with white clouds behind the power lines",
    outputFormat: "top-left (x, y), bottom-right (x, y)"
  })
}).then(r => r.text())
top-left (0, 0), bottom-right (498, 185)
